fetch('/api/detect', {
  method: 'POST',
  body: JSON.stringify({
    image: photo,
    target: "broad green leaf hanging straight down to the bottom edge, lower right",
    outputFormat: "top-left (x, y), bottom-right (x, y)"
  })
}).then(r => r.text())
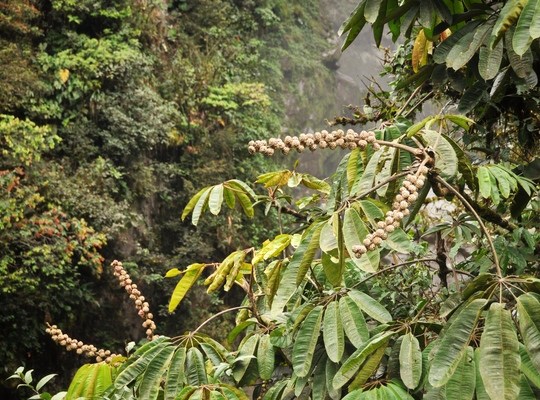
top-left (480, 303), bottom-right (521, 400)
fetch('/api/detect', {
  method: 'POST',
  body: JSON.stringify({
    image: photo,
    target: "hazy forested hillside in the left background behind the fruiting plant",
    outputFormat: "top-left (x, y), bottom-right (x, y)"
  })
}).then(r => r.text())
top-left (0, 0), bottom-right (338, 397)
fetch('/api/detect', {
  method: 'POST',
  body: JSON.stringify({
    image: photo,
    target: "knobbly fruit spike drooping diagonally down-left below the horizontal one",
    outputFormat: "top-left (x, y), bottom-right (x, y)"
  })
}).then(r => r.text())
top-left (352, 165), bottom-right (428, 257)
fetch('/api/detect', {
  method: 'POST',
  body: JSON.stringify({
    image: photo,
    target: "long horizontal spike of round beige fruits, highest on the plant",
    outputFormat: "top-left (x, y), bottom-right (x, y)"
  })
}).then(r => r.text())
top-left (248, 129), bottom-right (380, 156)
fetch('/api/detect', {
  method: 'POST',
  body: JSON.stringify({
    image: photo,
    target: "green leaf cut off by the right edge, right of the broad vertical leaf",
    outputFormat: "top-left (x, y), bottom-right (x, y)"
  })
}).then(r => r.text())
top-left (517, 293), bottom-right (540, 371)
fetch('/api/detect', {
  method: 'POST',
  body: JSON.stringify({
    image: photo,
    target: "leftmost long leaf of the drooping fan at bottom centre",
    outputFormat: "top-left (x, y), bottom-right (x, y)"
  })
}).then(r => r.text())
top-left (292, 306), bottom-right (323, 378)
